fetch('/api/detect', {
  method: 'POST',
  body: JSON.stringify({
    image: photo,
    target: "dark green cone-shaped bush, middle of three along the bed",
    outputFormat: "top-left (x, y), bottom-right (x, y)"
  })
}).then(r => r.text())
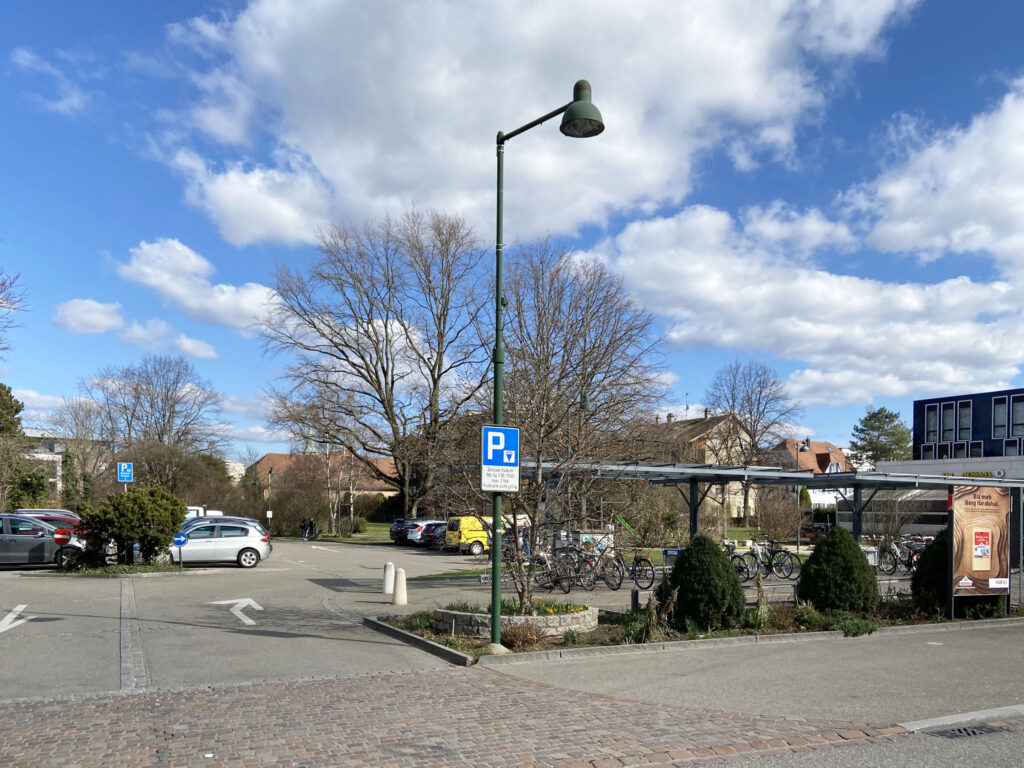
top-left (797, 527), bottom-right (879, 613)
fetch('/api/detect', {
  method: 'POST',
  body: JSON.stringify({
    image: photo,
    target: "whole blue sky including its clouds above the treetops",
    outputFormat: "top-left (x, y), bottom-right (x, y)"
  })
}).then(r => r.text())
top-left (6, 0), bottom-right (1024, 458)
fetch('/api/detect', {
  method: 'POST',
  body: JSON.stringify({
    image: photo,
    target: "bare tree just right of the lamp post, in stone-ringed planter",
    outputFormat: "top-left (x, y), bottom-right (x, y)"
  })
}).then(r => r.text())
top-left (493, 242), bottom-right (660, 609)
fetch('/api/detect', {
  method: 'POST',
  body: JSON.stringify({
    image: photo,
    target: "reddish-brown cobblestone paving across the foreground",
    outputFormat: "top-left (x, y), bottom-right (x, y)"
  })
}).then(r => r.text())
top-left (0, 668), bottom-right (906, 768)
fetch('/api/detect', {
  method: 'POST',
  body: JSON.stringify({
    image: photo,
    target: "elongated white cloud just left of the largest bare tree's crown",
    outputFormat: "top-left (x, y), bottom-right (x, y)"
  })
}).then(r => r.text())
top-left (117, 239), bottom-right (275, 330)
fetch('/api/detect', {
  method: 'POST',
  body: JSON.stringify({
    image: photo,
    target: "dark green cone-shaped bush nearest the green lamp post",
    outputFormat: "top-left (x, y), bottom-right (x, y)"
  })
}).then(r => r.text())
top-left (670, 536), bottom-right (745, 630)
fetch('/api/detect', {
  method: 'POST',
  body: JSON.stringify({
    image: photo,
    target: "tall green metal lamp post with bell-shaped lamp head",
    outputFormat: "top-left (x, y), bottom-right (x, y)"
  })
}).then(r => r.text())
top-left (490, 80), bottom-right (604, 645)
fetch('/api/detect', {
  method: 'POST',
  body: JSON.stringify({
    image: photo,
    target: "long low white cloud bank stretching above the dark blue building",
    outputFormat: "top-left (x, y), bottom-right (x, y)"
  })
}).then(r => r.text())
top-left (591, 206), bottom-right (1024, 404)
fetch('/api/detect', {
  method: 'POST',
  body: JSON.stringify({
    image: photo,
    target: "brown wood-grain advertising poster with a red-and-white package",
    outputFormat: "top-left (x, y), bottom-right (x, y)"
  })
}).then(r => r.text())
top-left (953, 485), bottom-right (1010, 597)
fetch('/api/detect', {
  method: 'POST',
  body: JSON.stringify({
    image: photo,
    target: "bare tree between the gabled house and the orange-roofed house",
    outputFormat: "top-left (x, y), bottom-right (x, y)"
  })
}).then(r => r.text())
top-left (705, 360), bottom-right (803, 525)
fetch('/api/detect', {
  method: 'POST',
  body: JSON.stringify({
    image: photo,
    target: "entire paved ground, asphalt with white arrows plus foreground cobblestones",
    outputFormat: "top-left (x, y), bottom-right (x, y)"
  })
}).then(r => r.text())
top-left (0, 541), bottom-right (1024, 768)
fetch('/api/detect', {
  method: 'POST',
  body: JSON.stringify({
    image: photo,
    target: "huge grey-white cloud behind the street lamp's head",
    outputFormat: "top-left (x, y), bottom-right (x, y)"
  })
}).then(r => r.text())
top-left (157, 0), bottom-right (913, 244)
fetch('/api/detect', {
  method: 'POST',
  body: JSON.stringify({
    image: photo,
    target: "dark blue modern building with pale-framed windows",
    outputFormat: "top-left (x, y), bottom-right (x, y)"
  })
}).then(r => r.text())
top-left (913, 389), bottom-right (1024, 461)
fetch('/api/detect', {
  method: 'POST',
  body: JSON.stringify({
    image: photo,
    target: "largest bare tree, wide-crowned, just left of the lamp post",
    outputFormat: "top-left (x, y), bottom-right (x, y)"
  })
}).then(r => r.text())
top-left (261, 212), bottom-right (487, 515)
